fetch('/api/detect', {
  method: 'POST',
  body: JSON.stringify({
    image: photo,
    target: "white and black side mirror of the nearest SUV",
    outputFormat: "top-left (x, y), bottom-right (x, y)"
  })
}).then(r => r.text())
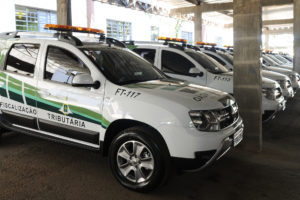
top-left (72, 73), bottom-right (100, 89)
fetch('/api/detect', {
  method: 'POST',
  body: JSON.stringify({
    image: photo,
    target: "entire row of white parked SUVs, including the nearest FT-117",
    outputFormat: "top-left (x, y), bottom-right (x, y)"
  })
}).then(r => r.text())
top-left (0, 24), bottom-right (299, 191)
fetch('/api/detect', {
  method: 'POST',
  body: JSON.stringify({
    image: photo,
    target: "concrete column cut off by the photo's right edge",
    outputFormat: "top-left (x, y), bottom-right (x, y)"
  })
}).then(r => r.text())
top-left (294, 0), bottom-right (300, 73)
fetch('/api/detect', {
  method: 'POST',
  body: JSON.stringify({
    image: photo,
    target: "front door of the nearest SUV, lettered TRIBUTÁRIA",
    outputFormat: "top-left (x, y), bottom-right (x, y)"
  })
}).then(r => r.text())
top-left (37, 41), bottom-right (108, 148)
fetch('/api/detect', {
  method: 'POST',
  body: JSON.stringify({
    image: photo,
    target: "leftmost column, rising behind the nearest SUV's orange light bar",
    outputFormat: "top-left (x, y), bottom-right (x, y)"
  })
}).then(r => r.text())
top-left (57, 0), bottom-right (72, 25)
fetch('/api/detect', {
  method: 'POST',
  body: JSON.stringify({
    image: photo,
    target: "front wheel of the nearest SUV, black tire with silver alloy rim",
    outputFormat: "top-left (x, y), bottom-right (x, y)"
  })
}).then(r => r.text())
top-left (109, 127), bottom-right (170, 192)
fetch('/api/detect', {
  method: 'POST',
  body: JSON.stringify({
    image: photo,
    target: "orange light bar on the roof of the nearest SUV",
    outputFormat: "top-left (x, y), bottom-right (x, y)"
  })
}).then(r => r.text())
top-left (44, 24), bottom-right (104, 35)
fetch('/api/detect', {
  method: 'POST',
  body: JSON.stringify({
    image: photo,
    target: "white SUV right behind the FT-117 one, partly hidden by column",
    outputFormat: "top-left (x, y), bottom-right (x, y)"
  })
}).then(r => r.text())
top-left (131, 41), bottom-right (286, 121)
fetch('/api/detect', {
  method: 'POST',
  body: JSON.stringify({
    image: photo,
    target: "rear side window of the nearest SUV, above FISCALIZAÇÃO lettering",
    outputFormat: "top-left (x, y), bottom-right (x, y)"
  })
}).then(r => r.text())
top-left (5, 44), bottom-right (40, 77)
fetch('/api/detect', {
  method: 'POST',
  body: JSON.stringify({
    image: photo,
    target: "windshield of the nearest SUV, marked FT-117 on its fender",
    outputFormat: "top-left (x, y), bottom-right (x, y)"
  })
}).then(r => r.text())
top-left (81, 46), bottom-right (166, 85)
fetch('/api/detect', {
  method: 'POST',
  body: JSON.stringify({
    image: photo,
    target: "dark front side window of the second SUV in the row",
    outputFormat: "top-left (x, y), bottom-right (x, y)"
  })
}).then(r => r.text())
top-left (162, 50), bottom-right (195, 75)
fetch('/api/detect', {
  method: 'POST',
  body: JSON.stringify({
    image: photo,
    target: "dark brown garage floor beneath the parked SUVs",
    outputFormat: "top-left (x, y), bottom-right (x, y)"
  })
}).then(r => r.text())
top-left (0, 94), bottom-right (300, 200)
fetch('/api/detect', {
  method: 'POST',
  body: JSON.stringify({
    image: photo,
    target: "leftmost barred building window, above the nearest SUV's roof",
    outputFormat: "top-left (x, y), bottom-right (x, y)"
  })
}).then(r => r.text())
top-left (15, 6), bottom-right (57, 32)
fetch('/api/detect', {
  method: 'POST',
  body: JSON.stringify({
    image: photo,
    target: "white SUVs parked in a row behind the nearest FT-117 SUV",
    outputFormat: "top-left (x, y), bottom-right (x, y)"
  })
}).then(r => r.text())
top-left (126, 37), bottom-right (300, 121)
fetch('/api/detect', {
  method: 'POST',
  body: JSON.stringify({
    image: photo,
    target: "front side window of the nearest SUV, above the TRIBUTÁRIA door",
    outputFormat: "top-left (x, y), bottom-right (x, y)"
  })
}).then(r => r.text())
top-left (44, 46), bottom-right (90, 84)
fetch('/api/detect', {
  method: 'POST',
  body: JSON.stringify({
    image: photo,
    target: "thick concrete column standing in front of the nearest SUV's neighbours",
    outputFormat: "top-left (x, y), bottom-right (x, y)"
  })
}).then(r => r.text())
top-left (233, 0), bottom-right (262, 151)
